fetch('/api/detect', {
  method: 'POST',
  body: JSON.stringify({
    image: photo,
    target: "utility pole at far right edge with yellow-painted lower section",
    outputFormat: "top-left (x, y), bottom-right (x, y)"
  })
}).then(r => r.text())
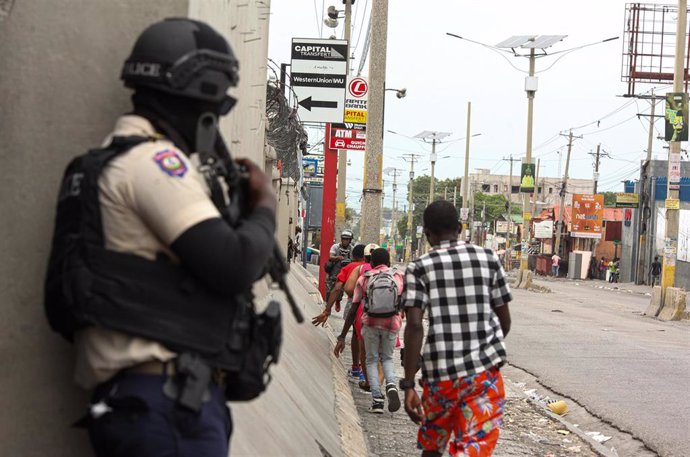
top-left (661, 0), bottom-right (688, 290)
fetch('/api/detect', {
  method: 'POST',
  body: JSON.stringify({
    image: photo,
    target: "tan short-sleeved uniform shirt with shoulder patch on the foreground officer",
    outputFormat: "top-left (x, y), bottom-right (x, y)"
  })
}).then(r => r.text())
top-left (74, 115), bottom-right (220, 389)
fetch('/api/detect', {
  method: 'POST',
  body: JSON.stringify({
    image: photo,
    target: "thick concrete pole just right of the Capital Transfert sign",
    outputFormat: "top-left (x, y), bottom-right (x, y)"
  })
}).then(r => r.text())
top-left (361, 0), bottom-right (388, 244)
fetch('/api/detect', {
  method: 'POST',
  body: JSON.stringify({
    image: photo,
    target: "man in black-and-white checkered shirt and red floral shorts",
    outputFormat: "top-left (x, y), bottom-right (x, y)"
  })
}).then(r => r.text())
top-left (400, 201), bottom-right (512, 457)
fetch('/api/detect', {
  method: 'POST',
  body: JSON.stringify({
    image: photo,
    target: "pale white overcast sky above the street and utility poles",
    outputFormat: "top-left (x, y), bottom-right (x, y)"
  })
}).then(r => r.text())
top-left (269, 0), bottom-right (672, 208)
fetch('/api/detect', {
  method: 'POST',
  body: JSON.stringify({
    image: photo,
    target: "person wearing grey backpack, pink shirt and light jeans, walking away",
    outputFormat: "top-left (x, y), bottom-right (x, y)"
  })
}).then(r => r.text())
top-left (334, 248), bottom-right (403, 413)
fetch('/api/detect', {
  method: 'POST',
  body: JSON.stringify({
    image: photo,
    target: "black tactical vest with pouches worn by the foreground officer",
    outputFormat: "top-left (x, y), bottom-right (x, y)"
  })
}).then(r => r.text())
top-left (44, 137), bottom-right (282, 401)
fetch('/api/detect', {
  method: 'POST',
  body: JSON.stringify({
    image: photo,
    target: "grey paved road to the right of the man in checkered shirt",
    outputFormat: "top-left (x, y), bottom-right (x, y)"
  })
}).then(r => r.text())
top-left (507, 281), bottom-right (690, 457)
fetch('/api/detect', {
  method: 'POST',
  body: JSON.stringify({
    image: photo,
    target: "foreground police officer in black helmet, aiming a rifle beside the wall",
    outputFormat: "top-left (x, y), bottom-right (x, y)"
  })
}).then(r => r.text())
top-left (45, 18), bottom-right (280, 457)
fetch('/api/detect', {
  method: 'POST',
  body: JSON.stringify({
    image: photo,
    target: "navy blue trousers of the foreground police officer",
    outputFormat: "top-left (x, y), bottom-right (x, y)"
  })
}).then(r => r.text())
top-left (88, 373), bottom-right (232, 457)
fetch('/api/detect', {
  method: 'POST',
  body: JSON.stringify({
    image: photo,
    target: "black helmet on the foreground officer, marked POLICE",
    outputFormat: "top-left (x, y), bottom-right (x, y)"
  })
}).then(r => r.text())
top-left (121, 18), bottom-right (239, 103)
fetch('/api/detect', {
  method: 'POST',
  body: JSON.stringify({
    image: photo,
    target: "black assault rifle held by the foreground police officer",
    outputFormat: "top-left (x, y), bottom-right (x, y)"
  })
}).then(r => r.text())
top-left (196, 113), bottom-right (304, 324)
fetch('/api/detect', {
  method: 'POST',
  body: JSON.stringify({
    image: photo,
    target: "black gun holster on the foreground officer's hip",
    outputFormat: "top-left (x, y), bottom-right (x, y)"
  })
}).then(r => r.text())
top-left (163, 352), bottom-right (211, 413)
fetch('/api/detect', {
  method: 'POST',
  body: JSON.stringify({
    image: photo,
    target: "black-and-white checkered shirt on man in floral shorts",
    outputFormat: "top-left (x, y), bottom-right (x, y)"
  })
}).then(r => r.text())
top-left (403, 241), bottom-right (513, 382)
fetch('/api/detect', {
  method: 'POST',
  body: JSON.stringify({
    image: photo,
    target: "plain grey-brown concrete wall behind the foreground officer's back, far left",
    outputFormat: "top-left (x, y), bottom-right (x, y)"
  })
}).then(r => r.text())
top-left (0, 0), bottom-right (187, 457)
